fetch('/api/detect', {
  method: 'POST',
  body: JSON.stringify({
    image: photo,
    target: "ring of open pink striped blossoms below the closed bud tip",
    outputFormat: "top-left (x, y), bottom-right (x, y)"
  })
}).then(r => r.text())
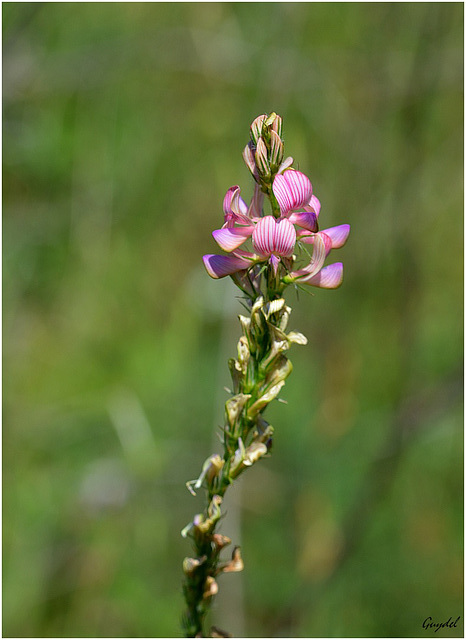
top-left (203, 168), bottom-right (350, 289)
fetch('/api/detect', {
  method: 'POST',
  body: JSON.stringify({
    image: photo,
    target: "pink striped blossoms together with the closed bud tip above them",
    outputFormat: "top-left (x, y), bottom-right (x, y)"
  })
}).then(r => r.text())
top-left (203, 114), bottom-right (350, 293)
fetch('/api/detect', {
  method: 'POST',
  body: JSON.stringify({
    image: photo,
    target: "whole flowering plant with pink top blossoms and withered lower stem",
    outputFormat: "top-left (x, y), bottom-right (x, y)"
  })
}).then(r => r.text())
top-left (182, 113), bottom-right (350, 637)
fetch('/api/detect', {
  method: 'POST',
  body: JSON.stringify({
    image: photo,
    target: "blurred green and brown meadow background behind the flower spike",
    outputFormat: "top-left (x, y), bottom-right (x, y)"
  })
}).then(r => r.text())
top-left (2, 3), bottom-right (463, 637)
